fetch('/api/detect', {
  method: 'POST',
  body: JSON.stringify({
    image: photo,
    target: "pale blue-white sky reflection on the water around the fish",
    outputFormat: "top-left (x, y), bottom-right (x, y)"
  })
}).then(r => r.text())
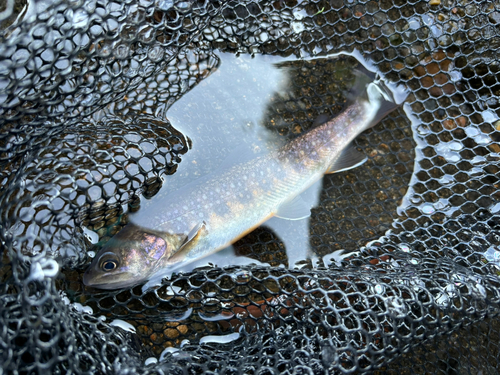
top-left (87, 49), bottom-right (412, 290)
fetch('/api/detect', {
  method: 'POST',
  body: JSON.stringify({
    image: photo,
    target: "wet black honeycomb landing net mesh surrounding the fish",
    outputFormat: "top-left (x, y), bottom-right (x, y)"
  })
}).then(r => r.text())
top-left (0, 0), bottom-right (500, 374)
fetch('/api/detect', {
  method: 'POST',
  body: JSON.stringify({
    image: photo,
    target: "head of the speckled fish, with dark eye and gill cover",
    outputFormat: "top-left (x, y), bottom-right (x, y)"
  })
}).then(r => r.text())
top-left (83, 224), bottom-right (179, 289)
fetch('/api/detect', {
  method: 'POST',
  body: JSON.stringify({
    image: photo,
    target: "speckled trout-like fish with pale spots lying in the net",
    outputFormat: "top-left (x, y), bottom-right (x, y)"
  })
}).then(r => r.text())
top-left (83, 77), bottom-right (406, 289)
